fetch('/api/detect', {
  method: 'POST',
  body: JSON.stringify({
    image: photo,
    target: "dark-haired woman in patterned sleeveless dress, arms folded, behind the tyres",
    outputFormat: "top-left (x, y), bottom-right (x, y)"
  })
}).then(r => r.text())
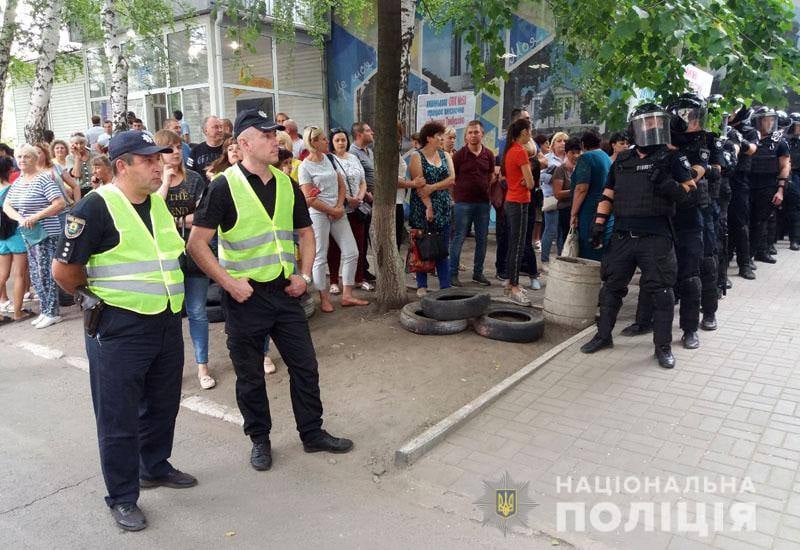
top-left (408, 121), bottom-right (456, 297)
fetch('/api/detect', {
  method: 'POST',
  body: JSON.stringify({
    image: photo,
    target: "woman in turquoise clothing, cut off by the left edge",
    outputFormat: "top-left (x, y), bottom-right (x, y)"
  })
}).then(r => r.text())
top-left (0, 157), bottom-right (30, 321)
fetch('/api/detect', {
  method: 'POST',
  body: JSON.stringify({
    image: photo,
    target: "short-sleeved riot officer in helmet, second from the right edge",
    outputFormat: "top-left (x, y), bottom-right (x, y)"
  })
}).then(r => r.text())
top-left (750, 107), bottom-right (791, 264)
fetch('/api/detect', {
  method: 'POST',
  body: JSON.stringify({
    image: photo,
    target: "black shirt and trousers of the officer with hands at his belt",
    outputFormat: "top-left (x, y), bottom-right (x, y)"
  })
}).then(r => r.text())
top-left (193, 163), bottom-right (322, 443)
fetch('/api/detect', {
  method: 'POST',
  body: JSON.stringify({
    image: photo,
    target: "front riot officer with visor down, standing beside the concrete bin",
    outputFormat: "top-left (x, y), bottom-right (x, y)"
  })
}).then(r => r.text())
top-left (581, 103), bottom-right (696, 368)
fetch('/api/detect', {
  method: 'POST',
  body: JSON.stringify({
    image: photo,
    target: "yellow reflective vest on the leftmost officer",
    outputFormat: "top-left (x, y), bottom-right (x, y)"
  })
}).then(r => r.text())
top-left (86, 184), bottom-right (184, 315)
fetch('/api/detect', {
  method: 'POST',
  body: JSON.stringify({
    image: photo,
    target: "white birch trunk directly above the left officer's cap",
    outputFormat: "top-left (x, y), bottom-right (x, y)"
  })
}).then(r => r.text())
top-left (100, 0), bottom-right (128, 133)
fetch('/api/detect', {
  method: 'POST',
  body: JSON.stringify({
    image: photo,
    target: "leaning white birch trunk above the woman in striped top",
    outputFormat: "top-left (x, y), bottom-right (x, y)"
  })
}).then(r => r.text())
top-left (25, 0), bottom-right (64, 143)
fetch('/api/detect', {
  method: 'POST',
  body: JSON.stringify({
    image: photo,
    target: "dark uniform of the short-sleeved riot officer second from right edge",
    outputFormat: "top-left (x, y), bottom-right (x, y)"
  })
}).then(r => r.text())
top-left (750, 132), bottom-right (789, 263)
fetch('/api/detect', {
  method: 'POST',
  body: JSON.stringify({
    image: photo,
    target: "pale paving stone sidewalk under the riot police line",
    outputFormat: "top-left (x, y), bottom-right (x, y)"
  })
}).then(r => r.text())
top-left (409, 246), bottom-right (800, 550)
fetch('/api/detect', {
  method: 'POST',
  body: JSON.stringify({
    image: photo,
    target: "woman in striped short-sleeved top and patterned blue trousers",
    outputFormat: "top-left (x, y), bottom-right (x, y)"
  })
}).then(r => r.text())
top-left (3, 144), bottom-right (69, 328)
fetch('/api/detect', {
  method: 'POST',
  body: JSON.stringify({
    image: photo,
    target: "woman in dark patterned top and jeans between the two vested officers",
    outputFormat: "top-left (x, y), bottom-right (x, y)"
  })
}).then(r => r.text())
top-left (153, 130), bottom-right (219, 390)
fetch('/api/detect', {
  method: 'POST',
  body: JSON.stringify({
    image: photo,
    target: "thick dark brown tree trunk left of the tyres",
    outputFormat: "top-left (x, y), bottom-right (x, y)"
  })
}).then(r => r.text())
top-left (372, 0), bottom-right (406, 311)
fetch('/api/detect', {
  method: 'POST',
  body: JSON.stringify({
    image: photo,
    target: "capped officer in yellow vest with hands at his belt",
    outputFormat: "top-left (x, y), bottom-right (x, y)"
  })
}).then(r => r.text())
top-left (187, 110), bottom-right (353, 470)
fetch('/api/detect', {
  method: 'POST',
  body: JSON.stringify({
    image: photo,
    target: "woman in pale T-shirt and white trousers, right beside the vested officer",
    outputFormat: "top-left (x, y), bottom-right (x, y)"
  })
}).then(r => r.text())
top-left (297, 126), bottom-right (369, 313)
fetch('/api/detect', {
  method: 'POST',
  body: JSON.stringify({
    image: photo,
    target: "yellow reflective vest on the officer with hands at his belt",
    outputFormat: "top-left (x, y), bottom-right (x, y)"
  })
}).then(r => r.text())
top-left (218, 164), bottom-right (294, 283)
